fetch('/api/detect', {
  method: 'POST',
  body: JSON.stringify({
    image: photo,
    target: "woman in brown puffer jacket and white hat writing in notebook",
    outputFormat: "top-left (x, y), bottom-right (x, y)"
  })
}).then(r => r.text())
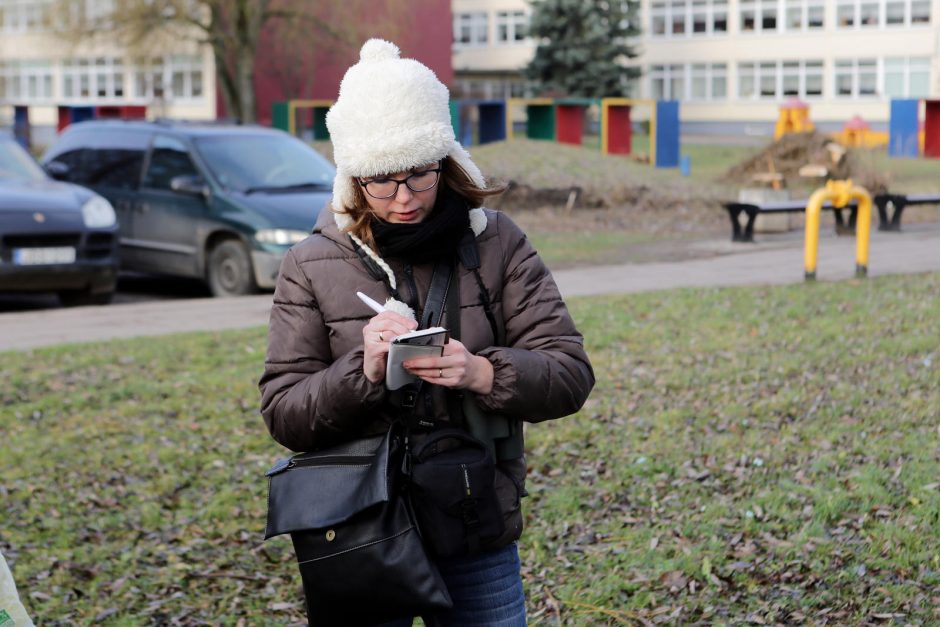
top-left (260, 40), bottom-right (594, 625)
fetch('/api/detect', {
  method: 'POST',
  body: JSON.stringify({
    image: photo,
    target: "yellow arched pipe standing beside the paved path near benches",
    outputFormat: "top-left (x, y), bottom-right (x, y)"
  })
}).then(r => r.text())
top-left (803, 179), bottom-right (871, 281)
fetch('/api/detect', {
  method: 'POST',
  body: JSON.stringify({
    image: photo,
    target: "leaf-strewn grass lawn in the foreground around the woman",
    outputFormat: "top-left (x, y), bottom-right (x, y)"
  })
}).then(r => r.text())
top-left (0, 274), bottom-right (940, 625)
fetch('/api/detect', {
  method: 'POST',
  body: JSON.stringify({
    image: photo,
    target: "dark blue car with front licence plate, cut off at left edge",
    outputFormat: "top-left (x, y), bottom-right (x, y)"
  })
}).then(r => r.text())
top-left (0, 137), bottom-right (118, 305)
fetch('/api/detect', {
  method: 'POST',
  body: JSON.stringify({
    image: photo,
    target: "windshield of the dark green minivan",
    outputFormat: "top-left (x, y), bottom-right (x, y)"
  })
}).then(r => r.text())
top-left (194, 132), bottom-right (335, 191)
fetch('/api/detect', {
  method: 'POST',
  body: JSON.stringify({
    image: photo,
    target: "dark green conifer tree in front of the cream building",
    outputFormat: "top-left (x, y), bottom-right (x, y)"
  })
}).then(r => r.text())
top-left (526, 0), bottom-right (640, 98)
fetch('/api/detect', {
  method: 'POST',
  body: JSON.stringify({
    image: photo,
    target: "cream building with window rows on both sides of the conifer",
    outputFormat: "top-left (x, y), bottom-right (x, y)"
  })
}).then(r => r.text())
top-left (452, 0), bottom-right (940, 135)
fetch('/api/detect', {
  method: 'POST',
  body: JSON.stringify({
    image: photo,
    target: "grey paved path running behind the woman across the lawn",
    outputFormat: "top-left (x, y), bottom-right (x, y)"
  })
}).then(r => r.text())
top-left (0, 225), bottom-right (940, 351)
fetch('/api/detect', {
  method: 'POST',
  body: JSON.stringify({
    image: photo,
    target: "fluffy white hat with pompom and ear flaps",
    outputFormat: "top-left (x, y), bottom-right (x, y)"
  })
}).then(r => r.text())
top-left (326, 39), bottom-right (485, 229)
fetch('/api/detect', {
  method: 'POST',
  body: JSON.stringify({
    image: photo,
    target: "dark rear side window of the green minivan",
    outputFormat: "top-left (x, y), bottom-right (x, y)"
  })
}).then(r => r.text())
top-left (44, 129), bottom-right (148, 189)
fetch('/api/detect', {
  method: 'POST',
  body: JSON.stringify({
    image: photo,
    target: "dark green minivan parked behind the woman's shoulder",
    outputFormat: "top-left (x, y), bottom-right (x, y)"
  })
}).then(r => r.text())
top-left (42, 120), bottom-right (335, 296)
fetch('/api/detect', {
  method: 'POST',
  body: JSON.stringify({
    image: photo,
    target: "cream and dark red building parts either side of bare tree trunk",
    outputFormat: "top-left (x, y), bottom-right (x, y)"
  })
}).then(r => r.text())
top-left (0, 0), bottom-right (453, 145)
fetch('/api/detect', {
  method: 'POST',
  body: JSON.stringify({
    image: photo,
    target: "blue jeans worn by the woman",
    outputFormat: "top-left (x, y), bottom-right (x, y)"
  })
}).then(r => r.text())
top-left (381, 542), bottom-right (526, 627)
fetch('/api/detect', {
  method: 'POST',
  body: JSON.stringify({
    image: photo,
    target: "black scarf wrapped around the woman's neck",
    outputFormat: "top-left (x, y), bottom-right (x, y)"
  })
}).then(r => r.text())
top-left (372, 186), bottom-right (470, 264)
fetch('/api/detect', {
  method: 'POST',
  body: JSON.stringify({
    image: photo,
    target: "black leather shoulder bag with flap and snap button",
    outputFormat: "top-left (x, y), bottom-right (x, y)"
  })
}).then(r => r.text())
top-left (265, 426), bottom-right (452, 626)
